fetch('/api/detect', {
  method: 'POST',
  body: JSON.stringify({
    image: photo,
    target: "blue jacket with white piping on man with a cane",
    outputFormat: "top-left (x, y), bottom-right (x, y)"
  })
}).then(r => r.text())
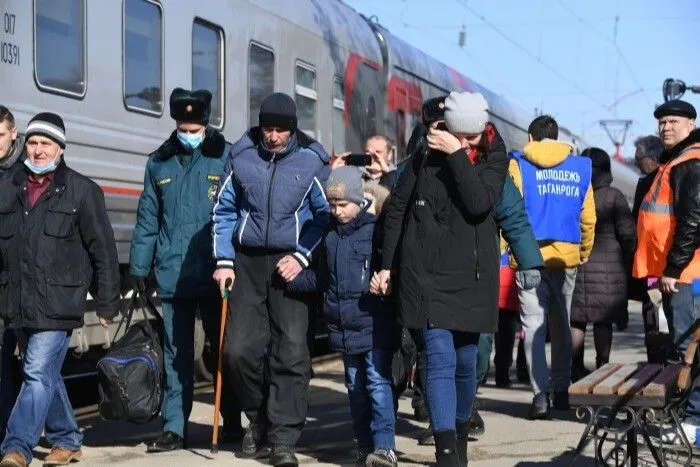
top-left (213, 127), bottom-right (330, 267)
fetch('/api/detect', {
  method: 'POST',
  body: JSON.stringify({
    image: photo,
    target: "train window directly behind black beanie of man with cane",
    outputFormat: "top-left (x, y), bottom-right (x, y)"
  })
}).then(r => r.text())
top-left (248, 43), bottom-right (275, 127)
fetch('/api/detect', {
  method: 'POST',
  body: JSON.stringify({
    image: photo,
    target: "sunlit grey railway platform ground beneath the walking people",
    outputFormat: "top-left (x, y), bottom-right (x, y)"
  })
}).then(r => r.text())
top-left (38, 302), bottom-right (688, 467)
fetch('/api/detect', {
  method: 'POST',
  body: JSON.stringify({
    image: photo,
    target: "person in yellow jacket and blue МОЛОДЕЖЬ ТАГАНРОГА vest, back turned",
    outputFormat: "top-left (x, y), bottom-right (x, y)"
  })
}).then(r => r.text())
top-left (509, 115), bottom-right (596, 419)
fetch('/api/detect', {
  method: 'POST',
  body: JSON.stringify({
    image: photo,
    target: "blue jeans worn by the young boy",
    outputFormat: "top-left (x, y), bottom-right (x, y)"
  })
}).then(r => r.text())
top-left (343, 349), bottom-right (396, 452)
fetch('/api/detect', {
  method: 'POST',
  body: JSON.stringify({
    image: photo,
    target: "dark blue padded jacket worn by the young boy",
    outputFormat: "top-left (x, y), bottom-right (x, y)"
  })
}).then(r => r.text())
top-left (289, 205), bottom-right (400, 355)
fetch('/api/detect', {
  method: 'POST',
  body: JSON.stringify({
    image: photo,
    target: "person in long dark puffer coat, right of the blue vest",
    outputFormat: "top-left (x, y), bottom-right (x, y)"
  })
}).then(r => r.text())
top-left (571, 148), bottom-right (636, 381)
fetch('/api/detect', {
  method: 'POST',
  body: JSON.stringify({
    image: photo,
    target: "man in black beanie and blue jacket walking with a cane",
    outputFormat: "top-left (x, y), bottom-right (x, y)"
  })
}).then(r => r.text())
top-left (214, 93), bottom-right (330, 466)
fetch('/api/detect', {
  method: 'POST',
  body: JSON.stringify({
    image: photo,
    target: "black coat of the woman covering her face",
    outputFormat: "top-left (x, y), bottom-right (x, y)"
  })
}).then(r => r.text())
top-left (382, 124), bottom-right (508, 333)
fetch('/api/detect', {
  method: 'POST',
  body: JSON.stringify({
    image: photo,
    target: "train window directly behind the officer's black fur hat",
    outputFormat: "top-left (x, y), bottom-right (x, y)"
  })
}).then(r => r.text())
top-left (192, 19), bottom-right (224, 129)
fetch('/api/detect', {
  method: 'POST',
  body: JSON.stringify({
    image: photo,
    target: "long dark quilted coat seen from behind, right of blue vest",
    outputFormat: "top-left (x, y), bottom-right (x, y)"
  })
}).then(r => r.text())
top-left (571, 173), bottom-right (636, 323)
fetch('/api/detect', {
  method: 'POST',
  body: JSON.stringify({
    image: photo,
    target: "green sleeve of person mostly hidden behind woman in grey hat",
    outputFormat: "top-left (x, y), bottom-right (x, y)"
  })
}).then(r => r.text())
top-left (494, 177), bottom-right (544, 270)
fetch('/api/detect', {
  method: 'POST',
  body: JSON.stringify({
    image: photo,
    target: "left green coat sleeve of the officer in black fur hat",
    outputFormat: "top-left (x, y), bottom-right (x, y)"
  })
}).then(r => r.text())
top-left (129, 163), bottom-right (160, 277)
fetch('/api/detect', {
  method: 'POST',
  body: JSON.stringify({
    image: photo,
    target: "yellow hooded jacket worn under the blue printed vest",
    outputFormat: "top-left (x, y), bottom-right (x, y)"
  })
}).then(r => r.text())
top-left (508, 140), bottom-right (596, 269)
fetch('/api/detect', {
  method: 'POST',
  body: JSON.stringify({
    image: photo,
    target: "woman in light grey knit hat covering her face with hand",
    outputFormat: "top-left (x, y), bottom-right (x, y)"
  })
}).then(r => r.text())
top-left (372, 92), bottom-right (508, 467)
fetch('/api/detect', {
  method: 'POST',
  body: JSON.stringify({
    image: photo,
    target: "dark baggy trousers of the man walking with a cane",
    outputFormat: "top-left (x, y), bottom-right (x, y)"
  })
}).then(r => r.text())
top-left (224, 250), bottom-right (311, 446)
